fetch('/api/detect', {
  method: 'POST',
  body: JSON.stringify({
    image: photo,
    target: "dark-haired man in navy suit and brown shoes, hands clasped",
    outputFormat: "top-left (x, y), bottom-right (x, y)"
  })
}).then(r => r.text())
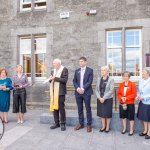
top-left (73, 57), bottom-right (93, 132)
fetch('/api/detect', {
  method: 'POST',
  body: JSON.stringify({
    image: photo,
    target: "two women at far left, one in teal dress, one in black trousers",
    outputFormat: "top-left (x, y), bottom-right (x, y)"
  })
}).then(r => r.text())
top-left (0, 65), bottom-right (29, 124)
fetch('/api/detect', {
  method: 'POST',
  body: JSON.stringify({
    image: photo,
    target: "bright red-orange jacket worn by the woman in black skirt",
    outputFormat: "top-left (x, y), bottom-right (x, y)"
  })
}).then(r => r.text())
top-left (118, 81), bottom-right (136, 104)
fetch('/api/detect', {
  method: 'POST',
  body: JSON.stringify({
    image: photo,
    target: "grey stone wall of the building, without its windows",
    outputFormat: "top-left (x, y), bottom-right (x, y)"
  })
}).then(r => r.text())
top-left (0, 0), bottom-right (150, 105)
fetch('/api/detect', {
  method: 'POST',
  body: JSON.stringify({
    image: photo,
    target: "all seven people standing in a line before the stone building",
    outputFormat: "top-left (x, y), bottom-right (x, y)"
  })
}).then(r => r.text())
top-left (0, 57), bottom-right (150, 139)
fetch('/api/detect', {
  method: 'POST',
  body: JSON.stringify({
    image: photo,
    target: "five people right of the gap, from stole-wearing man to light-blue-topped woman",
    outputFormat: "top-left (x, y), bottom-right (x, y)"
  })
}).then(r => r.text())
top-left (49, 57), bottom-right (150, 139)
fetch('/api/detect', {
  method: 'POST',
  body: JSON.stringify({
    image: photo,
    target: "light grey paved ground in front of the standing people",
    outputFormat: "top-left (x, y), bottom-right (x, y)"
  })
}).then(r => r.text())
top-left (0, 109), bottom-right (150, 150)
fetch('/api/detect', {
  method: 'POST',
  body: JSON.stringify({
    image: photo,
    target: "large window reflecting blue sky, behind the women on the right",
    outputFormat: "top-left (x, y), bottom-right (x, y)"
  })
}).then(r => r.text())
top-left (107, 29), bottom-right (142, 76)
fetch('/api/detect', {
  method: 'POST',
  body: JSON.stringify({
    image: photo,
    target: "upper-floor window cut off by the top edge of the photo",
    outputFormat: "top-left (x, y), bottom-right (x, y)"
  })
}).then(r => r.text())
top-left (20, 0), bottom-right (46, 11)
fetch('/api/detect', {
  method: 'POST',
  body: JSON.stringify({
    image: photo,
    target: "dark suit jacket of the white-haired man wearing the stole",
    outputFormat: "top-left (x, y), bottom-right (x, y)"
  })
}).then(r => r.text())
top-left (51, 67), bottom-right (68, 95)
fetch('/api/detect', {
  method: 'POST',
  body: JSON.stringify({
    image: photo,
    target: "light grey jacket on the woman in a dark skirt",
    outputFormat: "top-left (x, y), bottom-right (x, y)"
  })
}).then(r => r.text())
top-left (95, 77), bottom-right (114, 100)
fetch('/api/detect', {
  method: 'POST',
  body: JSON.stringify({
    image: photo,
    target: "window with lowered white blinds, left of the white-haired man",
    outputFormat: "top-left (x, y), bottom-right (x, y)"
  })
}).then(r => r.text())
top-left (20, 35), bottom-right (47, 80)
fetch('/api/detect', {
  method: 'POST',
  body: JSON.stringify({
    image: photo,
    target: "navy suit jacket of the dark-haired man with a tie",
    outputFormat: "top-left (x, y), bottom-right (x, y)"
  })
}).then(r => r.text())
top-left (73, 67), bottom-right (93, 95)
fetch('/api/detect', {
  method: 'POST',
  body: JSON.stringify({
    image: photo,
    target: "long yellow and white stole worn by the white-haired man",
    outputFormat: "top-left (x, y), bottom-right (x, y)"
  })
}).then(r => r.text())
top-left (50, 66), bottom-right (64, 112)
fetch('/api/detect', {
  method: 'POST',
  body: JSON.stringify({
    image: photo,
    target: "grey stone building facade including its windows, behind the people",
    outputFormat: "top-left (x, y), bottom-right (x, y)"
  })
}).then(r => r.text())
top-left (0, 0), bottom-right (150, 108)
